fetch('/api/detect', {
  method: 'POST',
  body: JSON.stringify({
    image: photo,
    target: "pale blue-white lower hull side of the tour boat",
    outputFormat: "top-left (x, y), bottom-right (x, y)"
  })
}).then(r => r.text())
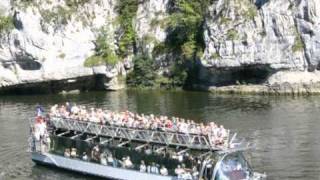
top-left (31, 152), bottom-right (177, 180)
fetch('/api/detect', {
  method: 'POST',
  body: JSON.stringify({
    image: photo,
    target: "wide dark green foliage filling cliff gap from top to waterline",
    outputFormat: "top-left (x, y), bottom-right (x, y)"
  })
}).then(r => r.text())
top-left (153, 0), bottom-right (210, 87)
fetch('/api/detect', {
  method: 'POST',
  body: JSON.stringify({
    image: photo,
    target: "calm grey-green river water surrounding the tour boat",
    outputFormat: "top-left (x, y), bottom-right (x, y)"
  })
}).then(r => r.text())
top-left (0, 90), bottom-right (320, 180)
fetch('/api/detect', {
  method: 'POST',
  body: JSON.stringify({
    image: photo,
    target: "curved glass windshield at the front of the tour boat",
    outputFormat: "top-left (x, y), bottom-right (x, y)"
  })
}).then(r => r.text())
top-left (214, 152), bottom-right (252, 180)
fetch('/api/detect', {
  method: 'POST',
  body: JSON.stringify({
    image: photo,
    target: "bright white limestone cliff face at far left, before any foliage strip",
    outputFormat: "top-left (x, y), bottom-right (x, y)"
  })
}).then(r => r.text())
top-left (0, 0), bottom-right (116, 90)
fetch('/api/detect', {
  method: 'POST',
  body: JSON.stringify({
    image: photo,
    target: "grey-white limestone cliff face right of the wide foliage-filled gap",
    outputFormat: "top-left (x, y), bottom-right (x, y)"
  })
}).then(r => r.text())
top-left (201, 0), bottom-right (320, 85)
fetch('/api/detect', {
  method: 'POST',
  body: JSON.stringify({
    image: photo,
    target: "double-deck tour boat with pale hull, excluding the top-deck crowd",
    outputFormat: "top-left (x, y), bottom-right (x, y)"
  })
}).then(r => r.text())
top-left (30, 116), bottom-right (266, 180)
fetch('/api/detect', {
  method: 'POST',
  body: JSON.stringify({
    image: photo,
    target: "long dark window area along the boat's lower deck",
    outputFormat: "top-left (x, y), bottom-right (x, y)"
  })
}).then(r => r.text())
top-left (50, 133), bottom-right (198, 177)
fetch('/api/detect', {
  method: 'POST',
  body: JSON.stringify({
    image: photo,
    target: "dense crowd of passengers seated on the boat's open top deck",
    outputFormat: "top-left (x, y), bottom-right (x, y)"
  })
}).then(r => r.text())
top-left (50, 102), bottom-right (229, 145)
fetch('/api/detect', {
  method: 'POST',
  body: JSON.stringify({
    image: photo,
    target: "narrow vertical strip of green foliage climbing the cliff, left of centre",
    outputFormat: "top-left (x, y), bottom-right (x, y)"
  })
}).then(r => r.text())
top-left (116, 0), bottom-right (138, 57)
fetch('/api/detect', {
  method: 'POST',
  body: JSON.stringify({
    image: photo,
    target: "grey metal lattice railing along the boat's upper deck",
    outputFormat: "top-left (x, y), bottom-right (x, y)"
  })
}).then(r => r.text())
top-left (50, 117), bottom-right (228, 150)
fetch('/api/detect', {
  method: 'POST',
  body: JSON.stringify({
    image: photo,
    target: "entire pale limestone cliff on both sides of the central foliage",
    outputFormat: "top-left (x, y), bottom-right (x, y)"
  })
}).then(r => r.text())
top-left (0, 0), bottom-right (320, 95)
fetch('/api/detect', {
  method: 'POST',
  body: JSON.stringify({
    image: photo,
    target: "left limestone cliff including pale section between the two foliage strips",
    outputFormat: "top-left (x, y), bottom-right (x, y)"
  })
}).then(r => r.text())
top-left (0, 0), bottom-right (168, 89)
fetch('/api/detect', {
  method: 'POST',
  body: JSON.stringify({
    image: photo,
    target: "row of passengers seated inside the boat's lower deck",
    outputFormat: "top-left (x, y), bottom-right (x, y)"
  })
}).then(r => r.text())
top-left (64, 146), bottom-right (199, 180)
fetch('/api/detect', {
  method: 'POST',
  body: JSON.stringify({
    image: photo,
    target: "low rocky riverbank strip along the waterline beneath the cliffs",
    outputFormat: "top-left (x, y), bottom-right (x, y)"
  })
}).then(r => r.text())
top-left (0, 81), bottom-right (320, 96)
